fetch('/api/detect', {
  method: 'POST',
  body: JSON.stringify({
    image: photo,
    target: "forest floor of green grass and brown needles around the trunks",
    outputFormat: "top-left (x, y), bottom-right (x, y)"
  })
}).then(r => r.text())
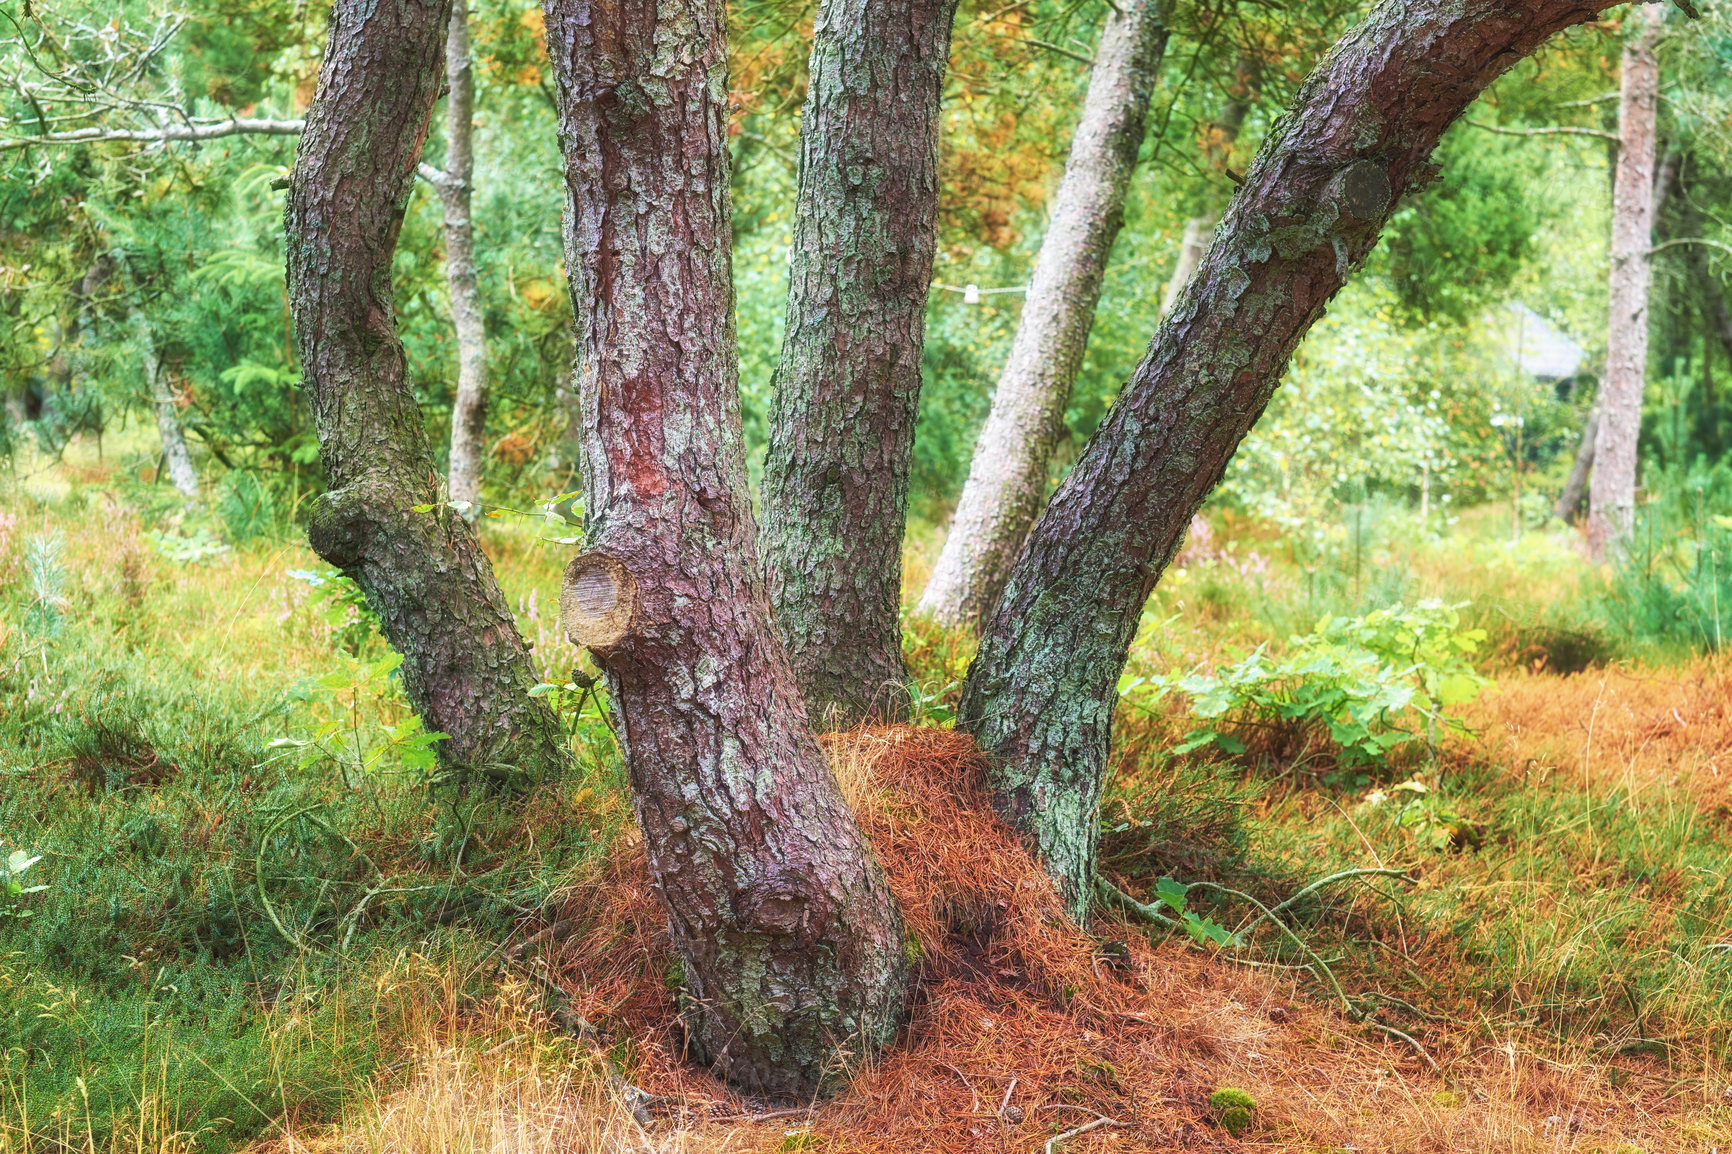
top-left (0, 438), bottom-right (1732, 1154)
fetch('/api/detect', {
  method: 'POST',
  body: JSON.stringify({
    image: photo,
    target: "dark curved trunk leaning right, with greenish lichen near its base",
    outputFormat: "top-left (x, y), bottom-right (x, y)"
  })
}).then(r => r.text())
top-left (961, 0), bottom-right (1606, 917)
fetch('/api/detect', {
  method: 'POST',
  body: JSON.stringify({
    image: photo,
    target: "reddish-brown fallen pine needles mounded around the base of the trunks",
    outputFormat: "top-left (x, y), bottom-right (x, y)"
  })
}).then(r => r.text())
top-left (270, 724), bottom-right (1715, 1154)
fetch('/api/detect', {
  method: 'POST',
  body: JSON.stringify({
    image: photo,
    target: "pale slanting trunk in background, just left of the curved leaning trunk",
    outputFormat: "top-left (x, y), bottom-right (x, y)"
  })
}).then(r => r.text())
top-left (920, 0), bottom-right (1167, 626)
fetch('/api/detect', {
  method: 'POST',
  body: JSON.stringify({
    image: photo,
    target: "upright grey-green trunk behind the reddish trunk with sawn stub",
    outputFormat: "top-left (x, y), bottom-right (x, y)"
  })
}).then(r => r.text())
top-left (760, 0), bottom-right (956, 728)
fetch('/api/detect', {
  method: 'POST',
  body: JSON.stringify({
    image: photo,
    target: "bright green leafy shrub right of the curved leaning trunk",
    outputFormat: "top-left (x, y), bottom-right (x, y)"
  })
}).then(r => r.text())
top-left (1121, 601), bottom-right (1486, 769)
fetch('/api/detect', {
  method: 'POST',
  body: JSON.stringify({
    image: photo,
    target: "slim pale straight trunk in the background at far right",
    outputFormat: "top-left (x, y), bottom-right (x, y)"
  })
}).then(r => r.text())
top-left (1588, 5), bottom-right (1664, 561)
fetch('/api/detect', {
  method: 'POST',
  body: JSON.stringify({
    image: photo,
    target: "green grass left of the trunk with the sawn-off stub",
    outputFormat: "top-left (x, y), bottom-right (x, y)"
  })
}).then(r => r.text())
top-left (0, 438), bottom-right (624, 1151)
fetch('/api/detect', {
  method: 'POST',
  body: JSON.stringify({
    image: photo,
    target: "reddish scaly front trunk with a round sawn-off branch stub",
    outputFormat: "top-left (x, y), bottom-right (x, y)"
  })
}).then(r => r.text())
top-left (546, 0), bottom-right (906, 1097)
